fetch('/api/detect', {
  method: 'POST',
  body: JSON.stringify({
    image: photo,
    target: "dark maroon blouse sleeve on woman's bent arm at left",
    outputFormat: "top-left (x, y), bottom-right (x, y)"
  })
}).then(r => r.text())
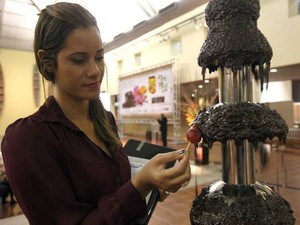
top-left (2, 118), bottom-right (146, 225)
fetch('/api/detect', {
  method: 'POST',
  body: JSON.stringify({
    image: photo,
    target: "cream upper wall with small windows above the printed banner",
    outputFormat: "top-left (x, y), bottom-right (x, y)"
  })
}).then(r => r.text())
top-left (105, 6), bottom-right (211, 94)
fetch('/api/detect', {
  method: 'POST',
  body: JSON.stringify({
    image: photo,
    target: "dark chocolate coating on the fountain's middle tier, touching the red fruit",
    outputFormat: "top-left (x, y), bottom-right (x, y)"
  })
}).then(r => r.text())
top-left (193, 102), bottom-right (289, 147)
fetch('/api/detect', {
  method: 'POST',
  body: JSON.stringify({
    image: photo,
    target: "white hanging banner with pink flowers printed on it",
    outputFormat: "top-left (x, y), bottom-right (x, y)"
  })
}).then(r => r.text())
top-left (119, 65), bottom-right (174, 118)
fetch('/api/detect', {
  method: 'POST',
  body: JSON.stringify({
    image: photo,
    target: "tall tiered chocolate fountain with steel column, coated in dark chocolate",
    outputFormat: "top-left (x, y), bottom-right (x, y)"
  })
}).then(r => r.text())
top-left (187, 0), bottom-right (295, 225)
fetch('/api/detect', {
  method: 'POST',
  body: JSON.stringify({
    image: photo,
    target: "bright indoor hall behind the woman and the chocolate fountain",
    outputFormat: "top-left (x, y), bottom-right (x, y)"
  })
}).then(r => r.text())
top-left (0, 0), bottom-right (300, 225)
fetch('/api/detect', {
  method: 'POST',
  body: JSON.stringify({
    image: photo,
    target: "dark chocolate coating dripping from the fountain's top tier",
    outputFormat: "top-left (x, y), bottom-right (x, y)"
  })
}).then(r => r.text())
top-left (198, 0), bottom-right (273, 88)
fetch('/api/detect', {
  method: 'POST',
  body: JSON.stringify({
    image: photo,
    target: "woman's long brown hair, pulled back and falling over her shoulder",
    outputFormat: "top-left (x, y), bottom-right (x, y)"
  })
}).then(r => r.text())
top-left (34, 2), bottom-right (121, 147)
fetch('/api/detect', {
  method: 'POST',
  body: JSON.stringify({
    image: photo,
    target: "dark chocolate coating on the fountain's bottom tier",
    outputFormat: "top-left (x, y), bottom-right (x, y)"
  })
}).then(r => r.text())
top-left (190, 182), bottom-right (295, 225)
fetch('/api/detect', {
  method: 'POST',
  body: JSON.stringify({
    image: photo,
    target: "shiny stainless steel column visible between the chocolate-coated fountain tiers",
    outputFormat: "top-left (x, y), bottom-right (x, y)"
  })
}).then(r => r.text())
top-left (218, 66), bottom-right (255, 185)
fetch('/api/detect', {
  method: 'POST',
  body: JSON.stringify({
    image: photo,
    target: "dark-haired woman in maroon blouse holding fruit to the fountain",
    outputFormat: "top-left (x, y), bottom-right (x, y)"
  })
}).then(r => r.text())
top-left (2, 3), bottom-right (191, 225)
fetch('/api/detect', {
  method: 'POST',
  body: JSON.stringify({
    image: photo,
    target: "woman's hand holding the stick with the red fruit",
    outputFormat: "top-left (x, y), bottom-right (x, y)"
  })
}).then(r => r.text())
top-left (132, 150), bottom-right (191, 199)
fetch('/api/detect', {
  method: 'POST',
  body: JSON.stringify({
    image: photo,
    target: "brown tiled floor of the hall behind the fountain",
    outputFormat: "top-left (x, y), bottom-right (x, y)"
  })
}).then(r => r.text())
top-left (0, 138), bottom-right (300, 225)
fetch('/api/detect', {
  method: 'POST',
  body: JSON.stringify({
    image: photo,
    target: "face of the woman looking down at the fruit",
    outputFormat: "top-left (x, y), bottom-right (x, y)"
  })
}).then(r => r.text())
top-left (55, 26), bottom-right (104, 100)
